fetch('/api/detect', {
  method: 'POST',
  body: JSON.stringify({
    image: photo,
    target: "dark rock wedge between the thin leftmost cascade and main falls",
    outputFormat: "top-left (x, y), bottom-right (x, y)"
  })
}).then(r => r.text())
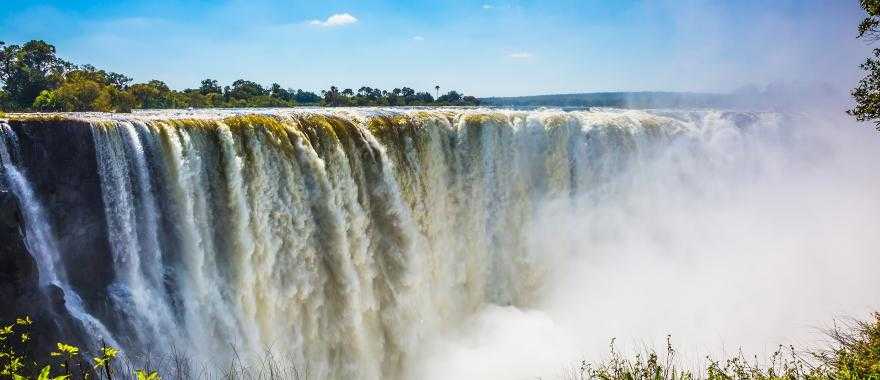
top-left (10, 120), bottom-right (113, 320)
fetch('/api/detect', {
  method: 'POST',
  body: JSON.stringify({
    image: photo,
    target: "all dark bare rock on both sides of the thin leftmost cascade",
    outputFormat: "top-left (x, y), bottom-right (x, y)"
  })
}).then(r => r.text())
top-left (0, 120), bottom-right (112, 350)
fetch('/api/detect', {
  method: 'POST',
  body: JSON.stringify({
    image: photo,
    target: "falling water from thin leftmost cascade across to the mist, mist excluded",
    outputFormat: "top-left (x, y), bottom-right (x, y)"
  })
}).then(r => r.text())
top-left (0, 110), bottom-right (840, 379)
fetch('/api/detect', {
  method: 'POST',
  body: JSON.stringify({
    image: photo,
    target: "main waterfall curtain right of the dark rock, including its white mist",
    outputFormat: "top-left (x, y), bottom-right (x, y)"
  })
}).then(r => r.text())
top-left (4, 110), bottom-right (880, 379)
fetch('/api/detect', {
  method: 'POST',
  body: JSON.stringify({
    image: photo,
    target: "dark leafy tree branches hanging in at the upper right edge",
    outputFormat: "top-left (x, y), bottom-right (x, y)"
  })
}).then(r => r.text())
top-left (847, 0), bottom-right (880, 130)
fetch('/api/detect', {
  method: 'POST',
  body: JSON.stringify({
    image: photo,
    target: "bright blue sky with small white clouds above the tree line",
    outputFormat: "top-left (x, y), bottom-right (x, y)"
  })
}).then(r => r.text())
top-left (0, 0), bottom-right (870, 96)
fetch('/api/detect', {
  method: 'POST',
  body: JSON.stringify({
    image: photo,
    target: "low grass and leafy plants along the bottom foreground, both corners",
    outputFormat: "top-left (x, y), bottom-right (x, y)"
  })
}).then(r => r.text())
top-left (0, 313), bottom-right (880, 380)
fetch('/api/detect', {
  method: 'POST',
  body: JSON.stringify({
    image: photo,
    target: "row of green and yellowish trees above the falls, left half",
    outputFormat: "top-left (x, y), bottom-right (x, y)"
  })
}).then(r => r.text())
top-left (0, 40), bottom-right (480, 112)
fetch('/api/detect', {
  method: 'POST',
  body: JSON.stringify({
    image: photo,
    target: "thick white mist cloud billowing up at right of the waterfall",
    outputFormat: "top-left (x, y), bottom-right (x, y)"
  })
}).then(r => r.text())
top-left (414, 113), bottom-right (880, 379)
